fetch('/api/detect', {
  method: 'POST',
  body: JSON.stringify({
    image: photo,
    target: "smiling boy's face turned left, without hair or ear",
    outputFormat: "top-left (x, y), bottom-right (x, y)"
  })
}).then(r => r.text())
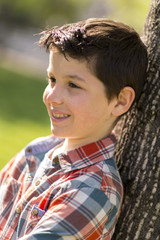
top-left (43, 50), bottom-right (115, 145)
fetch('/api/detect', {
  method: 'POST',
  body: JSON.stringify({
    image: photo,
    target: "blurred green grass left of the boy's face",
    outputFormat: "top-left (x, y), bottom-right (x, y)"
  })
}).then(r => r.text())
top-left (0, 67), bottom-right (50, 169)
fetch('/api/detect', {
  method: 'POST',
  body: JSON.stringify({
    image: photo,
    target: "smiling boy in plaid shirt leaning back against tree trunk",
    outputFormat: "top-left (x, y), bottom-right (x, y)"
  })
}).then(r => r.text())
top-left (0, 18), bottom-right (147, 240)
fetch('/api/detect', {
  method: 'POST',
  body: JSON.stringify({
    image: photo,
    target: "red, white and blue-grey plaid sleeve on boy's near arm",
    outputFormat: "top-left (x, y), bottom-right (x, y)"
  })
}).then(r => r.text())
top-left (19, 187), bottom-right (118, 240)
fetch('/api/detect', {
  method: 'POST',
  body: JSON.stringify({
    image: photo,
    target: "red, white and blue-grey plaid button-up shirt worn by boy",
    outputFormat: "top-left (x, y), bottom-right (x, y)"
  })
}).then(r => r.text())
top-left (0, 135), bottom-right (123, 240)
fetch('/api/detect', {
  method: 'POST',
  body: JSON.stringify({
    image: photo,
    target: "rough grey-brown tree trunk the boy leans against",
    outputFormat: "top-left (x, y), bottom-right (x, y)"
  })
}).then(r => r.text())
top-left (113, 0), bottom-right (160, 240)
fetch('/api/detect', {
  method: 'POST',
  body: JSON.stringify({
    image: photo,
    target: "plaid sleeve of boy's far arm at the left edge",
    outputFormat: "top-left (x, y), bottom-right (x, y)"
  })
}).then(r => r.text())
top-left (0, 150), bottom-right (26, 218)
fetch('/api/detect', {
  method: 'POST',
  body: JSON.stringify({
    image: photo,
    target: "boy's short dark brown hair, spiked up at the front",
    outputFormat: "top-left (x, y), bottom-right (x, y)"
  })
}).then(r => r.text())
top-left (39, 18), bottom-right (148, 100)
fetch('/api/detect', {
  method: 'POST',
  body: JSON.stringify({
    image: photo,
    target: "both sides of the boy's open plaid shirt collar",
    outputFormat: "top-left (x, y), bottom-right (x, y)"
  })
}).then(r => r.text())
top-left (25, 134), bottom-right (116, 169)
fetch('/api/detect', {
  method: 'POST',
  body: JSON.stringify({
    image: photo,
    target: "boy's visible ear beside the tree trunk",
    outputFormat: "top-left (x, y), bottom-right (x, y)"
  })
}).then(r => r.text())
top-left (112, 87), bottom-right (135, 117)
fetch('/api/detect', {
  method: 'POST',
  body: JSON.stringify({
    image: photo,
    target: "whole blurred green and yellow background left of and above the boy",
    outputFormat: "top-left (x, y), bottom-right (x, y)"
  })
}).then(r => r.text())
top-left (0, 0), bottom-right (150, 169)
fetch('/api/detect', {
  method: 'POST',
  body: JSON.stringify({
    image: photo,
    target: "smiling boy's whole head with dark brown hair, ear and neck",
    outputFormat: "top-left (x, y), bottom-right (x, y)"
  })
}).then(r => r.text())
top-left (40, 19), bottom-right (147, 144)
